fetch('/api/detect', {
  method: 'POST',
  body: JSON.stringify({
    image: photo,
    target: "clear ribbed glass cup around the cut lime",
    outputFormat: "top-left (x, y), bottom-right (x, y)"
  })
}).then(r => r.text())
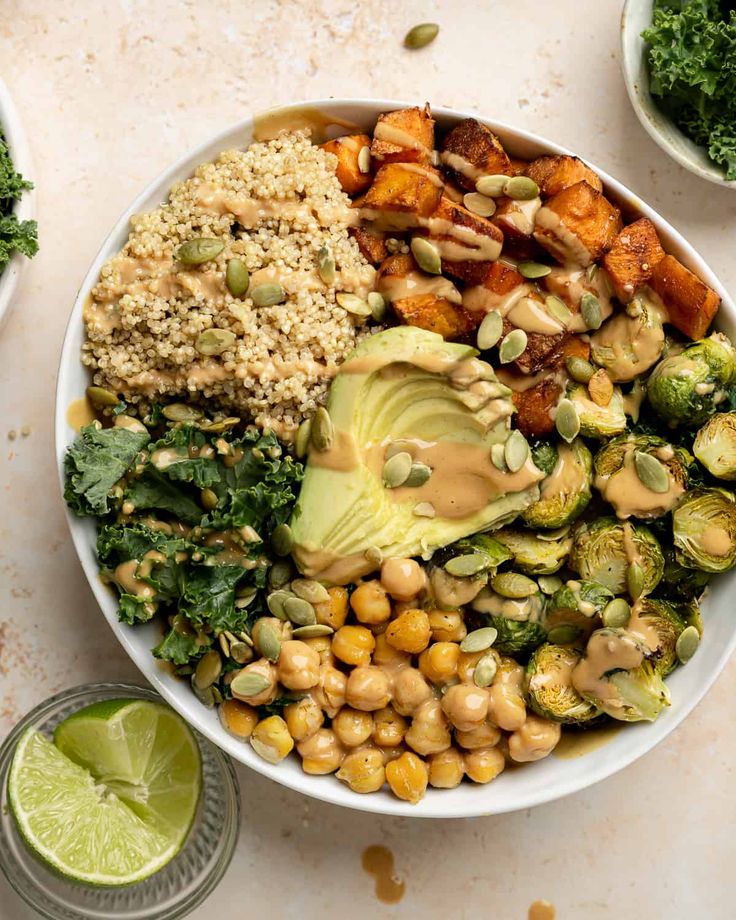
top-left (0, 683), bottom-right (240, 920)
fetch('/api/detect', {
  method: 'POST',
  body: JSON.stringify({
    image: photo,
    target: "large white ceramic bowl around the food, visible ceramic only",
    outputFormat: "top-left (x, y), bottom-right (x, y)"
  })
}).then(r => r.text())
top-left (56, 99), bottom-right (736, 818)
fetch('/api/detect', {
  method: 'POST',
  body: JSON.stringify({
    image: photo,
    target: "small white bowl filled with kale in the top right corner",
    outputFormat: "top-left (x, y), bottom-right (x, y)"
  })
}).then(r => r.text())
top-left (621, 0), bottom-right (736, 188)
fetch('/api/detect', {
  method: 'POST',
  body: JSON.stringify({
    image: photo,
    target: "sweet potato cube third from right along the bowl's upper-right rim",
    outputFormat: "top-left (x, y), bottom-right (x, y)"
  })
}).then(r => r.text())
top-left (534, 181), bottom-right (622, 266)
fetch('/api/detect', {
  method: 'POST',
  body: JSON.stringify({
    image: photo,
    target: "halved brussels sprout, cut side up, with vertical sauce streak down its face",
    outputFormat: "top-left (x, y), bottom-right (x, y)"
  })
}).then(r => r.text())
top-left (569, 517), bottom-right (664, 596)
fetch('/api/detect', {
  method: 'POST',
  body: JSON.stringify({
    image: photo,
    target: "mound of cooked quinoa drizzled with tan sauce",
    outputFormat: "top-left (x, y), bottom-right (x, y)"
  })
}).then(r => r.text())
top-left (82, 132), bottom-right (375, 436)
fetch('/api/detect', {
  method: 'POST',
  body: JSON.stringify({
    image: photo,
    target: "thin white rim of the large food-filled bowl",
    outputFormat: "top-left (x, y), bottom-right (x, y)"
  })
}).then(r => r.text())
top-left (55, 97), bottom-right (736, 818)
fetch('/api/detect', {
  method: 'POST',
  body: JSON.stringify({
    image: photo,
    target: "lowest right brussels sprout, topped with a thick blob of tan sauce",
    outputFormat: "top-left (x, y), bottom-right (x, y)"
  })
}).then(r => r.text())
top-left (572, 629), bottom-right (670, 722)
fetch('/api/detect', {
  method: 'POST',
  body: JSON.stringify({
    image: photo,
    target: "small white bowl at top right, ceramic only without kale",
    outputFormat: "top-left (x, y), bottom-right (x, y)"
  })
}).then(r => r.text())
top-left (621, 0), bottom-right (736, 189)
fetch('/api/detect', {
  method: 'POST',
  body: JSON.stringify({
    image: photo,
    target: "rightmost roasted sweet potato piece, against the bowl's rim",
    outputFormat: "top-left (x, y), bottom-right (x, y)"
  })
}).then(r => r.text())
top-left (649, 256), bottom-right (721, 339)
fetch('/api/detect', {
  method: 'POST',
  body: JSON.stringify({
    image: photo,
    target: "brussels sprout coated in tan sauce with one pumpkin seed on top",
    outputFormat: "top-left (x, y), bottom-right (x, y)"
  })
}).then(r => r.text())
top-left (594, 434), bottom-right (692, 519)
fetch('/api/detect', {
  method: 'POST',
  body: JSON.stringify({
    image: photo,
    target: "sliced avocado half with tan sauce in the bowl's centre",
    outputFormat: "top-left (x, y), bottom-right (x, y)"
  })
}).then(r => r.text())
top-left (291, 326), bottom-right (544, 584)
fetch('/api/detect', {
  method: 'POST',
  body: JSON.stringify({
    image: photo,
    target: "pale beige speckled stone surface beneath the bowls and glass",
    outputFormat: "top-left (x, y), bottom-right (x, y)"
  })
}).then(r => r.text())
top-left (0, 0), bottom-right (736, 920)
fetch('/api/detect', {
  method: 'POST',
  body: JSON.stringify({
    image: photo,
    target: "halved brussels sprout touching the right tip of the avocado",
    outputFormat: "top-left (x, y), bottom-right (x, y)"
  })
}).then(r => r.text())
top-left (522, 438), bottom-right (593, 529)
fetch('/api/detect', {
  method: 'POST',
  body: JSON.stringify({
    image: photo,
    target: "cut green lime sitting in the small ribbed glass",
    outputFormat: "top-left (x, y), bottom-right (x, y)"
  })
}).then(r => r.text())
top-left (8, 700), bottom-right (202, 885)
